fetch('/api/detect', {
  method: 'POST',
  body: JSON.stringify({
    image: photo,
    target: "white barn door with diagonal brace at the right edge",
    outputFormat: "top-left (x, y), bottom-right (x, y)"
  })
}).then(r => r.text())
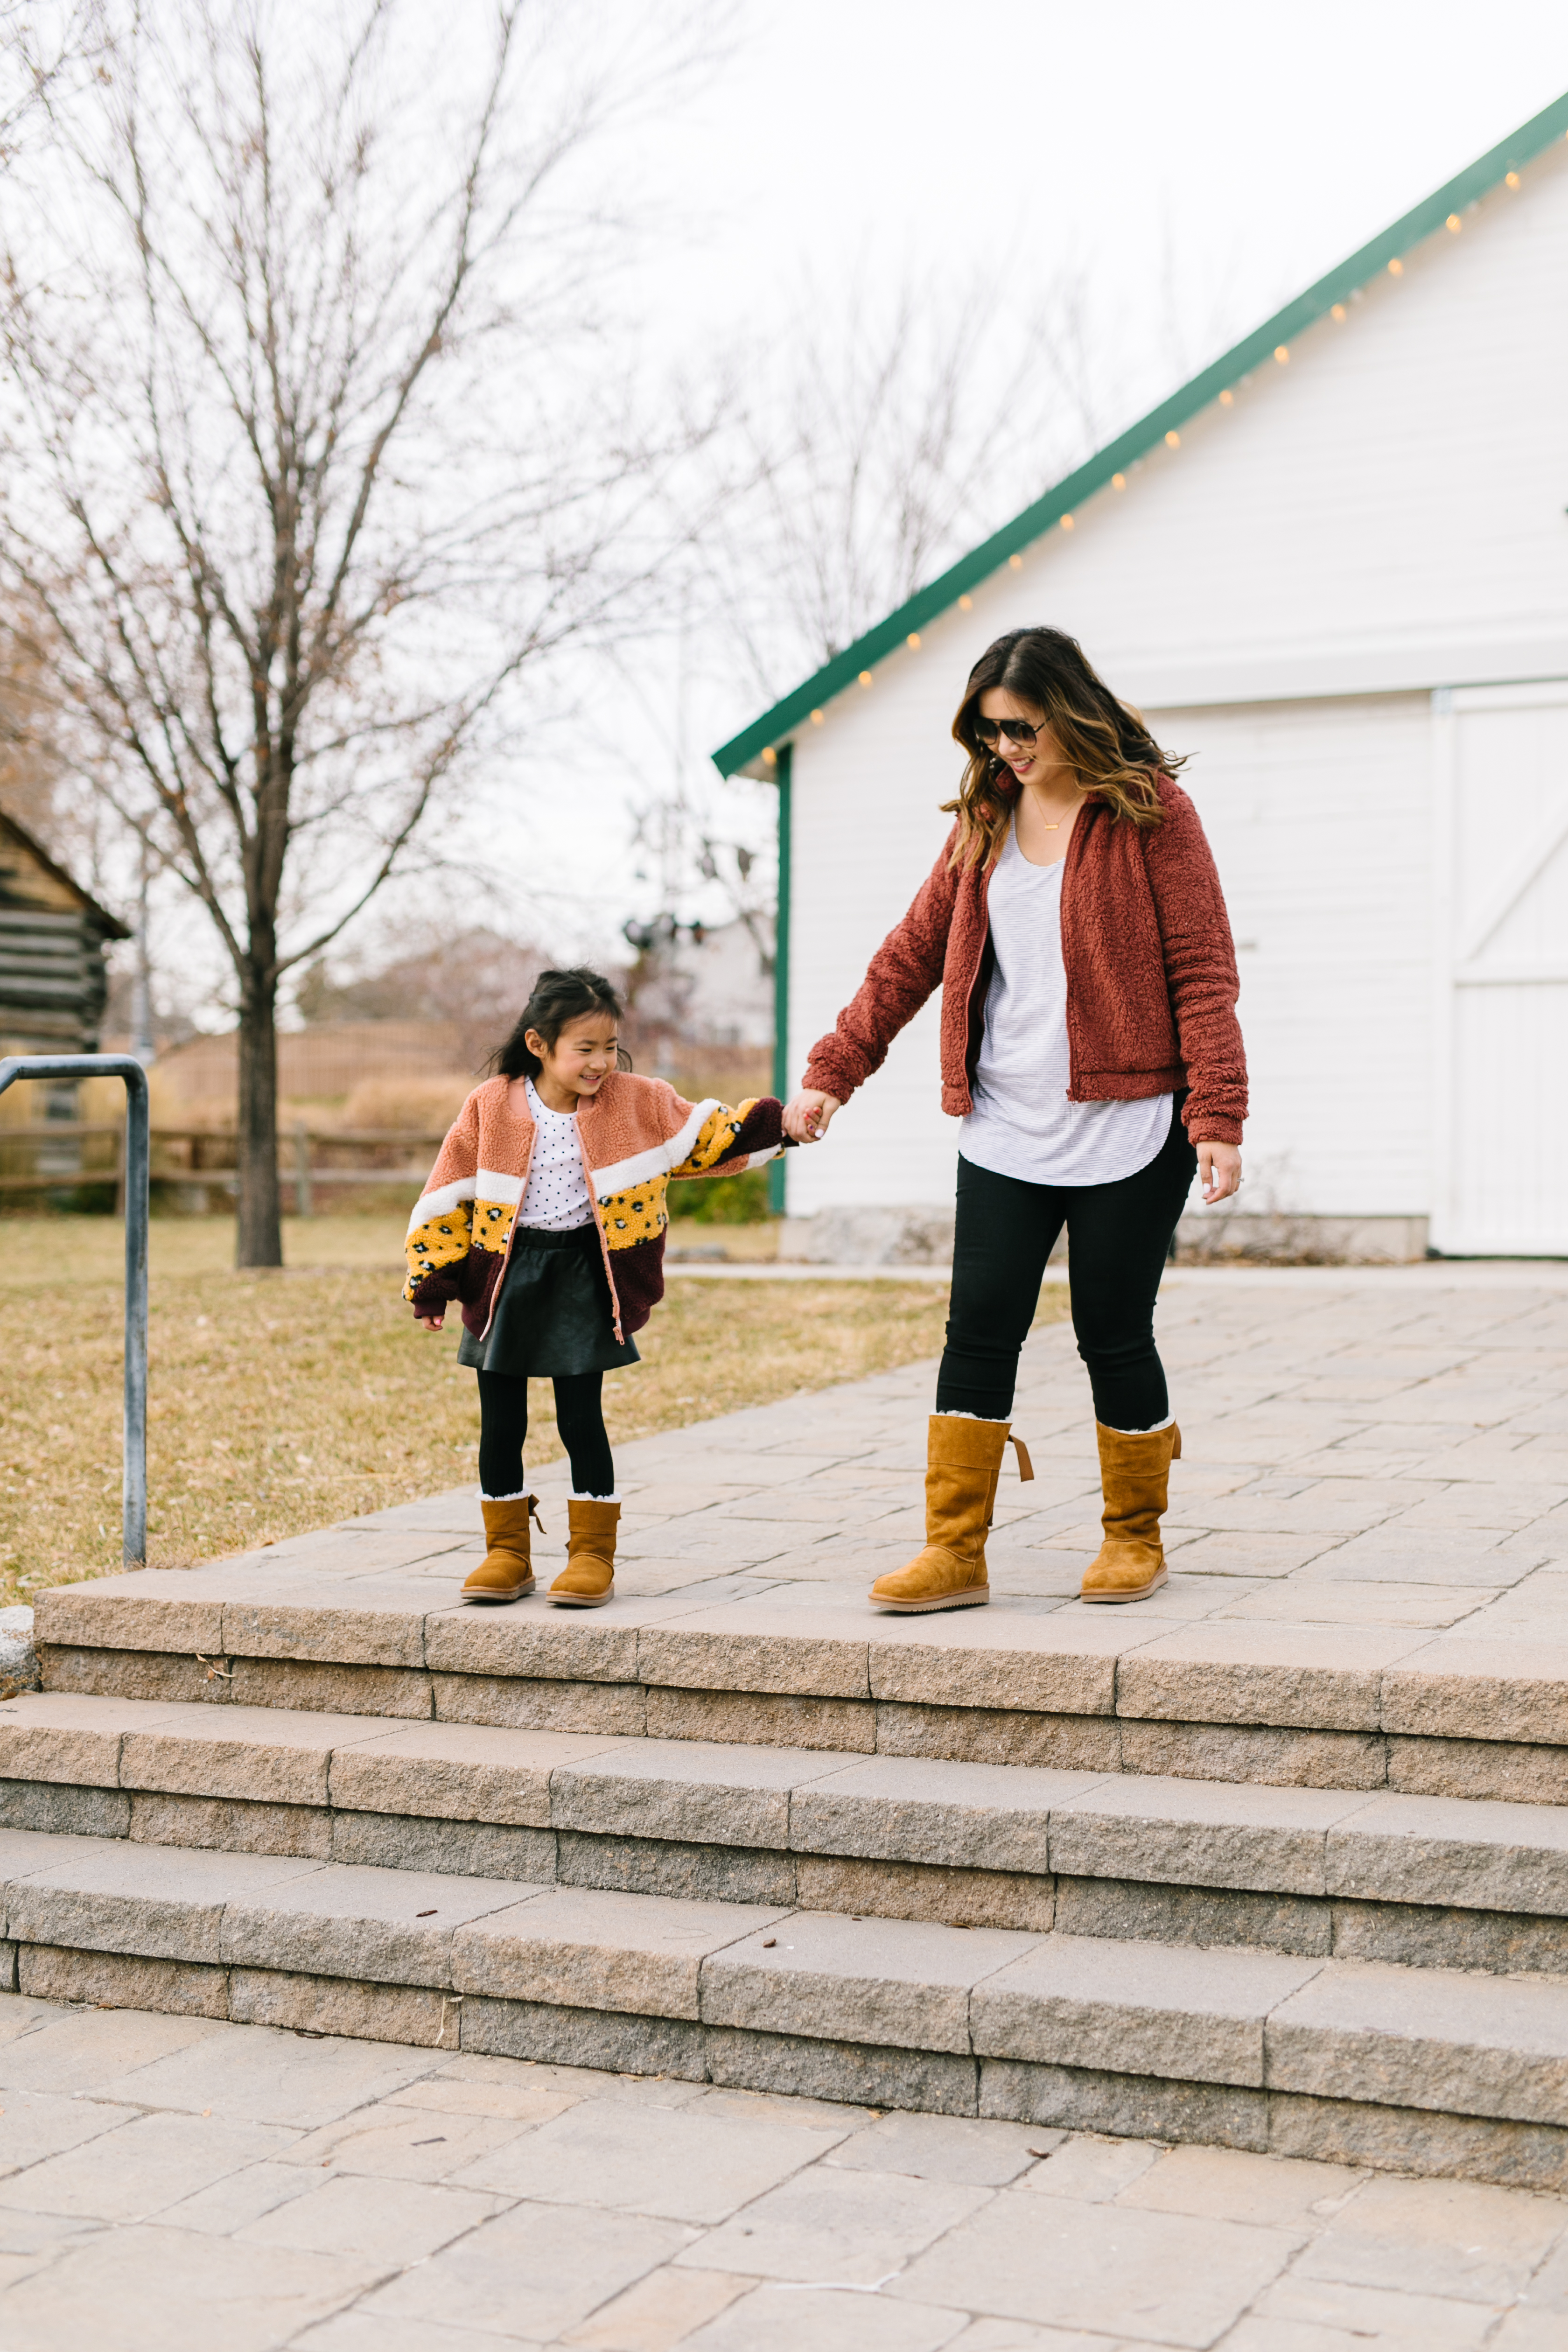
top-left (1432, 680), bottom-right (1568, 1256)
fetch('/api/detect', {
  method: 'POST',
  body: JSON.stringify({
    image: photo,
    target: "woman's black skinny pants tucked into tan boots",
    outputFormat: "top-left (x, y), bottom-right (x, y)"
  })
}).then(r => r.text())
top-left (936, 1099), bottom-right (1197, 1430)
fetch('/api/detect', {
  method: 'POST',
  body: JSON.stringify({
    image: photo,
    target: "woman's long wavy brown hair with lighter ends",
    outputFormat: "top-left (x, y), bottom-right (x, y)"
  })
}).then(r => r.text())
top-left (943, 628), bottom-right (1185, 866)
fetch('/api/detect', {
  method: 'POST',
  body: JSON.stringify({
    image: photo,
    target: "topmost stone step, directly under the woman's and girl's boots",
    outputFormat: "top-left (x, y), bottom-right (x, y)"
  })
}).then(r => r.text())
top-left (38, 1529), bottom-right (1568, 1804)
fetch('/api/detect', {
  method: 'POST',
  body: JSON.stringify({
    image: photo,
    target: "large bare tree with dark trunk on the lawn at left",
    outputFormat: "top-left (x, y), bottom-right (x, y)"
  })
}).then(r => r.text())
top-left (0, 0), bottom-right (714, 1266)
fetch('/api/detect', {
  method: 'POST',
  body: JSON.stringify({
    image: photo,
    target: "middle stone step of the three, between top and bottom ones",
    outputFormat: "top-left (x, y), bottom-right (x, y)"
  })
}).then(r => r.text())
top-left (0, 1694), bottom-right (1568, 1974)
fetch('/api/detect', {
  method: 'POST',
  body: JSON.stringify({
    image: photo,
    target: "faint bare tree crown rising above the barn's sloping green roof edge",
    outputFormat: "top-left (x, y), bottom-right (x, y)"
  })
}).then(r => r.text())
top-left (703, 268), bottom-right (1117, 696)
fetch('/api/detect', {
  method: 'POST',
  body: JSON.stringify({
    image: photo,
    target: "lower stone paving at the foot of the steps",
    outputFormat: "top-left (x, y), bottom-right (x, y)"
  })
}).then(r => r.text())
top-left (0, 1995), bottom-right (1568, 2352)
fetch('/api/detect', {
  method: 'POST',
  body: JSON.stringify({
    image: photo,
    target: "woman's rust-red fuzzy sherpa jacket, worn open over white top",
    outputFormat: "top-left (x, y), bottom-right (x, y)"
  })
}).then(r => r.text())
top-left (804, 776), bottom-right (1246, 1143)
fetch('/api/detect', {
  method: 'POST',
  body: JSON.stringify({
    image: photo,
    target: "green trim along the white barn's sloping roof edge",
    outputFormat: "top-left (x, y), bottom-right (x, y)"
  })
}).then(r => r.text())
top-left (712, 92), bottom-right (1568, 776)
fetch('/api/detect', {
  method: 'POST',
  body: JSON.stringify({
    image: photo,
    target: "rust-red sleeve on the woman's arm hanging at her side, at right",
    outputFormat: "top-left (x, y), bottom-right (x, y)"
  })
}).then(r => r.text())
top-left (1145, 783), bottom-right (1246, 1143)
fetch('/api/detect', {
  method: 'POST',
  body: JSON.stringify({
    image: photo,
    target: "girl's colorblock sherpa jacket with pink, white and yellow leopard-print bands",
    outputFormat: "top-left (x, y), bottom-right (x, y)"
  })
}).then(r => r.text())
top-left (402, 1070), bottom-right (783, 1338)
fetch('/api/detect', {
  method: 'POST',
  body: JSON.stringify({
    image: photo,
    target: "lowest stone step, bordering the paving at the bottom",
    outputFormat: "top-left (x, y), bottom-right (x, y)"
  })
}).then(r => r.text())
top-left (0, 1830), bottom-right (1568, 2187)
